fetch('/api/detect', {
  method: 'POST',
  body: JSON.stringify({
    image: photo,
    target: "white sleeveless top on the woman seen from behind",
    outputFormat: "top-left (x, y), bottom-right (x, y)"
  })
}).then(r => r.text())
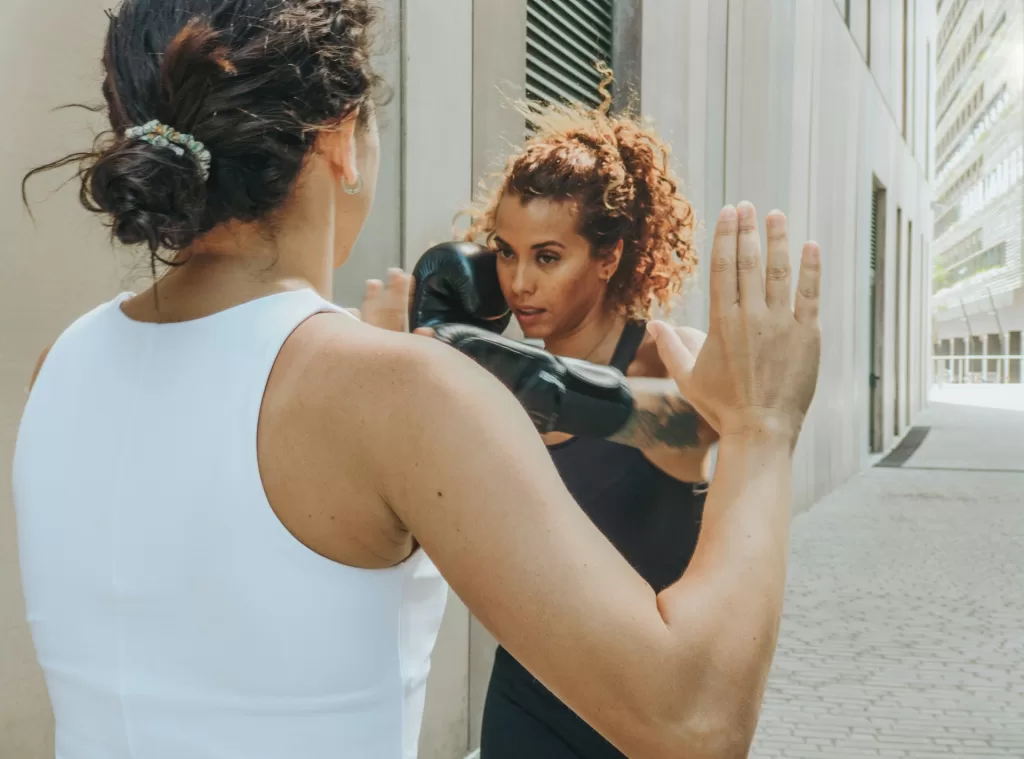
top-left (13, 290), bottom-right (447, 759)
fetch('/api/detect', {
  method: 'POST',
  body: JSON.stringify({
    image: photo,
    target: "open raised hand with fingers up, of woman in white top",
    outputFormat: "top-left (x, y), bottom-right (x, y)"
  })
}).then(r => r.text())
top-left (652, 203), bottom-right (821, 449)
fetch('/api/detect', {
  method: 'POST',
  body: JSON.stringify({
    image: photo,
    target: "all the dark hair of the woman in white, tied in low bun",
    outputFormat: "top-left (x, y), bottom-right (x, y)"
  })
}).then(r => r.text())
top-left (22, 0), bottom-right (386, 260)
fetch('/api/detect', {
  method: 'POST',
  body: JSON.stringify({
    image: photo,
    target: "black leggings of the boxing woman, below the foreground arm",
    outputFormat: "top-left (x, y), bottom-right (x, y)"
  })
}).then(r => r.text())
top-left (480, 648), bottom-right (626, 759)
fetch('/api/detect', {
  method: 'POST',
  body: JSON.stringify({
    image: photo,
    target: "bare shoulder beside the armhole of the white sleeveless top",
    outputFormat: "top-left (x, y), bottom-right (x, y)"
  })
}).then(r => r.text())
top-left (259, 313), bottom-right (525, 568)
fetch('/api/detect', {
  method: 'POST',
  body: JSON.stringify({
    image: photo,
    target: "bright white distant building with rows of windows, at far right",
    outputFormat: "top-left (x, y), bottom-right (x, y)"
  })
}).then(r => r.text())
top-left (933, 0), bottom-right (1024, 382)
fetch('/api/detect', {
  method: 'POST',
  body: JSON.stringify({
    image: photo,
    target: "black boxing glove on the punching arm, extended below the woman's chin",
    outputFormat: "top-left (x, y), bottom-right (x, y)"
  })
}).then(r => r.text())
top-left (435, 325), bottom-right (633, 438)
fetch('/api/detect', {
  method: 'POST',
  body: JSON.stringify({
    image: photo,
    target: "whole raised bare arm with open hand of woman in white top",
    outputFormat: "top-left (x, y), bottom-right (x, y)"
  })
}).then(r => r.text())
top-left (359, 203), bottom-right (819, 759)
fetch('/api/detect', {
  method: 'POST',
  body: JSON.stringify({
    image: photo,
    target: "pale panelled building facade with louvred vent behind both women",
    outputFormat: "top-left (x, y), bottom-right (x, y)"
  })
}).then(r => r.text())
top-left (0, 0), bottom-right (937, 759)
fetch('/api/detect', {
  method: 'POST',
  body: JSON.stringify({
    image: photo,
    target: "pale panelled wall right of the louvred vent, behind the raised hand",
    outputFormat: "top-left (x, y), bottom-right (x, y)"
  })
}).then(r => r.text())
top-left (626, 0), bottom-right (935, 508)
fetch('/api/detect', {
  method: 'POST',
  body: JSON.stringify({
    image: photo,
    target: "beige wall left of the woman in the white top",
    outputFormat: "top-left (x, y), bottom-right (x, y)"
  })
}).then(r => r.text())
top-left (0, 0), bottom-right (130, 759)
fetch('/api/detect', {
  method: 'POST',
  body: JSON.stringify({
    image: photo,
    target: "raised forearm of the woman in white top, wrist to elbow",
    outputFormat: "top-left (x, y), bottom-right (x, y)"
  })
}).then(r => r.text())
top-left (658, 437), bottom-right (792, 755)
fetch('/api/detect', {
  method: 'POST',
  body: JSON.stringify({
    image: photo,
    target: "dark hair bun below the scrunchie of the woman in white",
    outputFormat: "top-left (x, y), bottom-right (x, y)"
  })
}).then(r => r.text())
top-left (88, 139), bottom-right (206, 251)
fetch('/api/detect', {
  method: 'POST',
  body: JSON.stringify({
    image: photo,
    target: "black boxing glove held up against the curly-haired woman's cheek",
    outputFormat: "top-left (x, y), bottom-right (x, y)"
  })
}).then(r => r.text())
top-left (409, 242), bottom-right (512, 334)
